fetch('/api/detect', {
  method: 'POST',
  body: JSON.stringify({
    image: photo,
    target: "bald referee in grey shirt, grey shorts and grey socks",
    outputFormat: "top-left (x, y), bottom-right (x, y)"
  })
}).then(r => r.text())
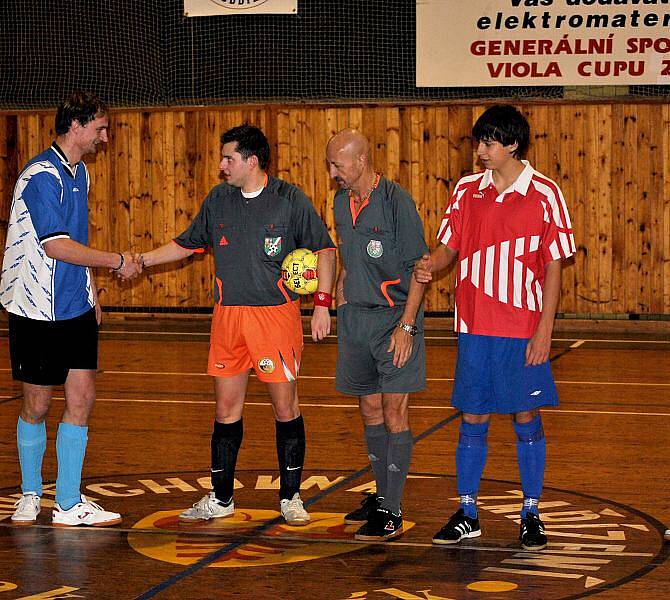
top-left (326, 129), bottom-right (427, 540)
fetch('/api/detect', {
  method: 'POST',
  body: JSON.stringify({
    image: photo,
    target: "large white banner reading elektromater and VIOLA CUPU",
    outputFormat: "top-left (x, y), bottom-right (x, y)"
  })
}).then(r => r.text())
top-left (416, 0), bottom-right (670, 87)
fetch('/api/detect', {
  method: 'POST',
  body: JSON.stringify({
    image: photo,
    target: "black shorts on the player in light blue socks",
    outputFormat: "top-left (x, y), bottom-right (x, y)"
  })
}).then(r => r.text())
top-left (9, 308), bottom-right (98, 385)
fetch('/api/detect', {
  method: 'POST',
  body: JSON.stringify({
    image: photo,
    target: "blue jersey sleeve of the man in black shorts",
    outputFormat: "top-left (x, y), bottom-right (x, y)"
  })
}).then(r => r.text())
top-left (21, 172), bottom-right (70, 244)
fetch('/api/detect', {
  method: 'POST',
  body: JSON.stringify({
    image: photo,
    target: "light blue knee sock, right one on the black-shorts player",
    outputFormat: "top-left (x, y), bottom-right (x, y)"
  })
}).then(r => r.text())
top-left (56, 423), bottom-right (88, 510)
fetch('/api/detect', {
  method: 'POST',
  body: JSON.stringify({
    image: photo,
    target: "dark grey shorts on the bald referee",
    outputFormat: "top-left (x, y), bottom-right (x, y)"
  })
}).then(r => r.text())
top-left (335, 304), bottom-right (426, 396)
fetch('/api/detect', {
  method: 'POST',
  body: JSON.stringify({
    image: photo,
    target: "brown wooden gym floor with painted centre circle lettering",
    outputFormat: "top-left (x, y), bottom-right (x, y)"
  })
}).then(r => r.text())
top-left (0, 320), bottom-right (670, 600)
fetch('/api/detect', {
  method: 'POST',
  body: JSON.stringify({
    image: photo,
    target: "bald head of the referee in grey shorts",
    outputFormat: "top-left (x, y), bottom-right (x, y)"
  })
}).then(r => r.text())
top-left (326, 129), bottom-right (374, 191)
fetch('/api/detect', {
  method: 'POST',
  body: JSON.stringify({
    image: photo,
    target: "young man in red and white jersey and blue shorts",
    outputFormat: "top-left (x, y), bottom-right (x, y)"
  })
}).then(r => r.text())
top-left (415, 105), bottom-right (575, 550)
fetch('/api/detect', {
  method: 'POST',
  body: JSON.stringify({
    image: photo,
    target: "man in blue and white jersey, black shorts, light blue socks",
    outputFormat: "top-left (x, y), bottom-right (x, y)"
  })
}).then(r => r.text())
top-left (0, 92), bottom-right (140, 526)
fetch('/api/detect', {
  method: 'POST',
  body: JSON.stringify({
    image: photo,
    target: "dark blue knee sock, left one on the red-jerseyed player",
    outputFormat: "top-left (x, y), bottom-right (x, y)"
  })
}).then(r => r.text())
top-left (456, 421), bottom-right (489, 519)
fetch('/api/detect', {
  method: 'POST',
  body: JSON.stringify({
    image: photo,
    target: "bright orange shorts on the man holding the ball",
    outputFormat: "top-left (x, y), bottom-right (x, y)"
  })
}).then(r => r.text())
top-left (207, 300), bottom-right (303, 382)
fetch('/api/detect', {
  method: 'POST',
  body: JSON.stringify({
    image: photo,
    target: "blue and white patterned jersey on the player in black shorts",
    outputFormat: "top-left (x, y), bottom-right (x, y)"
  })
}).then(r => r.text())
top-left (0, 142), bottom-right (95, 321)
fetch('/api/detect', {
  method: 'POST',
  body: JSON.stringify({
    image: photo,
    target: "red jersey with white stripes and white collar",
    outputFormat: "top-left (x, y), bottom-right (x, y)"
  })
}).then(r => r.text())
top-left (437, 161), bottom-right (575, 338)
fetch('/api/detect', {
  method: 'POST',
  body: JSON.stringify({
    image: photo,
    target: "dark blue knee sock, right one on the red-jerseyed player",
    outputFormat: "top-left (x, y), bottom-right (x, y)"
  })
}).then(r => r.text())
top-left (514, 415), bottom-right (547, 519)
